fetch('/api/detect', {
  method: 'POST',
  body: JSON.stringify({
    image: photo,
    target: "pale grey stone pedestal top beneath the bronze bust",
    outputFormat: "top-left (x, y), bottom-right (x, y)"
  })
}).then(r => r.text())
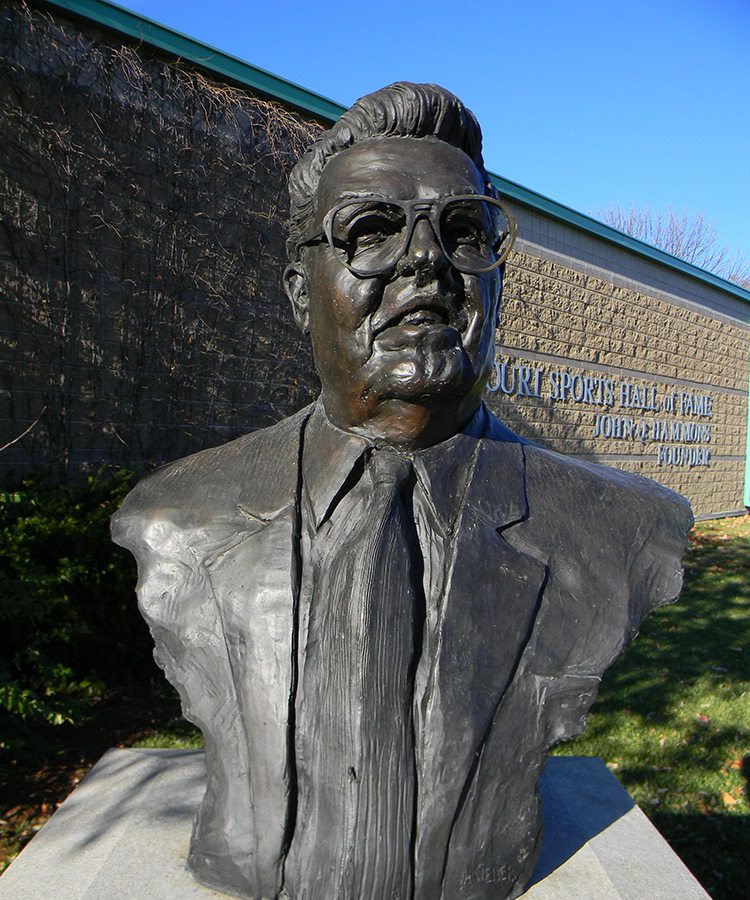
top-left (0, 750), bottom-right (708, 900)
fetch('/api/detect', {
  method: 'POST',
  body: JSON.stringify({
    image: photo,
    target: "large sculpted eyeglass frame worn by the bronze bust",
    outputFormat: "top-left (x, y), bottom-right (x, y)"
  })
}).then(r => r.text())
top-left (299, 194), bottom-right (518, 278)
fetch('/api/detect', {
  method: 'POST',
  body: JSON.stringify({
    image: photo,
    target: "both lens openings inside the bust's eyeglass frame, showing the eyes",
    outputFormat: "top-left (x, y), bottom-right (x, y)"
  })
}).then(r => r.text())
top-left (330, 198), bottom-right (501, 273)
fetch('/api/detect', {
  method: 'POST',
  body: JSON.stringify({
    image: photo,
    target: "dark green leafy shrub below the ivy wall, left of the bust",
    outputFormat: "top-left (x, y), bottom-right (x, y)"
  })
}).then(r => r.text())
top-left (0, 471), bottom-right (155, 756)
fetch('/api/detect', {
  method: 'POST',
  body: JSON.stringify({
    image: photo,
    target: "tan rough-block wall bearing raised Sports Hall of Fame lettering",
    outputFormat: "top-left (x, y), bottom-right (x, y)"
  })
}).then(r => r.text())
top-left (488, 241), bottom-right (750, 516)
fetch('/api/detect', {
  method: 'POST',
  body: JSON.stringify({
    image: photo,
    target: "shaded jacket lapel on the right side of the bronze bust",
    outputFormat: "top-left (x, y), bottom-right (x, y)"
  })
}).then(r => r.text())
top-left (416, 434), bottom-right (546, 897)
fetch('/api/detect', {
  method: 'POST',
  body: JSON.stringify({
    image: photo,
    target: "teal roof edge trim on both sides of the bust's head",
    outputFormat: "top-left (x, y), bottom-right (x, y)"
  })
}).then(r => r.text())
top-left (41, 0), bottom-right (750, 303)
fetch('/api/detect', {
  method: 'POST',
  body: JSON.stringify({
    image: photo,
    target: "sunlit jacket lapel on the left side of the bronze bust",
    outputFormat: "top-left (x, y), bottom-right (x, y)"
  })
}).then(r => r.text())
top-left (201, 416), bottom-right (306, 890)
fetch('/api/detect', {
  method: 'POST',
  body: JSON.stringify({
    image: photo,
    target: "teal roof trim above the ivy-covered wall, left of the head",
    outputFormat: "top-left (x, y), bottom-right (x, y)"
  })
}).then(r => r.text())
top-left (37, 0), bottom-right (346, 122)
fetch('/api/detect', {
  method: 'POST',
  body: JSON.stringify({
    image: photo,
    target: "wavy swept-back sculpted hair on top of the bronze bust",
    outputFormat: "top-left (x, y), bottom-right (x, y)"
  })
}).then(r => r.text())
top-left (287, 81), bottom-right (494, 263)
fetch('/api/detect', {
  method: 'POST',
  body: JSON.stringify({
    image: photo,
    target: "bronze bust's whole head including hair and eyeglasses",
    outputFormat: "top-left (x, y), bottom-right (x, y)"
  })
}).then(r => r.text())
top-left (285, 83), bottom-right (514, 450)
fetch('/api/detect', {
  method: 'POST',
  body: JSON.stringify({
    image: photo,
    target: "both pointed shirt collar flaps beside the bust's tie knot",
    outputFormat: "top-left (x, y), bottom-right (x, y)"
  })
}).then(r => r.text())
top-left (302, 400), bottom-right (487, 532)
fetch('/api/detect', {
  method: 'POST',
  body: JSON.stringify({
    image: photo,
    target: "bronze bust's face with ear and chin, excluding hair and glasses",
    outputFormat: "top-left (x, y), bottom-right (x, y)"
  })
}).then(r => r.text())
top-left (287, 137), bottom-right (501, 449)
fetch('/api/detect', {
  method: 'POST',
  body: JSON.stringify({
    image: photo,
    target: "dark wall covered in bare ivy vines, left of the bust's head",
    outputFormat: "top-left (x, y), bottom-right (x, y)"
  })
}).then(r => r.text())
top-left (0, 2), bottom-right (318, 484)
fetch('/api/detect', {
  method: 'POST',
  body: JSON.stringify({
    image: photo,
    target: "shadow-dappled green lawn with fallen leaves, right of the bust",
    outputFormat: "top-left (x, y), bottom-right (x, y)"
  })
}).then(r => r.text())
top-left (555, 516), bottom-right (750, 900)
